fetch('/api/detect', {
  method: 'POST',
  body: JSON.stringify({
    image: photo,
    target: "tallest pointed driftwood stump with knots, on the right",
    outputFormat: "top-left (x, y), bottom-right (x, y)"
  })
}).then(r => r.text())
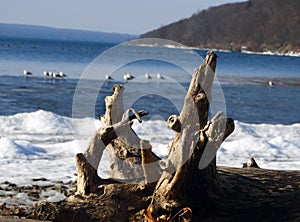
top-left (147, 52), bottom-right (234, 218)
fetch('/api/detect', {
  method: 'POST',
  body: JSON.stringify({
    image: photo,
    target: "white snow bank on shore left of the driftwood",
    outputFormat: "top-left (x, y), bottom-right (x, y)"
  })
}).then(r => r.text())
top-left (0, 110), bottom-right (99, 185)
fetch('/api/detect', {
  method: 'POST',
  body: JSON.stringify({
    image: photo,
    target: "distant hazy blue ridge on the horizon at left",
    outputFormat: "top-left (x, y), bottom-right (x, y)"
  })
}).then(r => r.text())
top-left (0, 23), bottom-right (137, 43)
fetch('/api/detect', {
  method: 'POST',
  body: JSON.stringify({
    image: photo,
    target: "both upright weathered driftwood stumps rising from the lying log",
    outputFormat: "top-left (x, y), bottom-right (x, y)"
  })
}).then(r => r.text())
top-left (76, 52), bottom-right (234, 218)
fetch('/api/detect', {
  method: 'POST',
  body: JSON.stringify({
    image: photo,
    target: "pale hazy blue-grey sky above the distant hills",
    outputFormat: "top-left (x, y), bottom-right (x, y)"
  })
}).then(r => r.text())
top-left (0, 0), bottom-right (245, 34)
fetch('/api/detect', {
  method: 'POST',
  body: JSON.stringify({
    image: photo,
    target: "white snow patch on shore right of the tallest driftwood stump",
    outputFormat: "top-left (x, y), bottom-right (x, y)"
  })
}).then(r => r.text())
top-left (217, 121), bottom-right (300, 170)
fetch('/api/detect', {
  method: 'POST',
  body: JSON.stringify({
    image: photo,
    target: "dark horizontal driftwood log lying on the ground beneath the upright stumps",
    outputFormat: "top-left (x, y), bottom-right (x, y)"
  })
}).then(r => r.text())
top-left (28, 167), bottom-right (300, 222)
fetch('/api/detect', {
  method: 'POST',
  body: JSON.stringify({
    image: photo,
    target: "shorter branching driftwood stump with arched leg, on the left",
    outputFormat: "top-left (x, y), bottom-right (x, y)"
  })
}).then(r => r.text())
top-left (76, 85), bottom-right (160, 195)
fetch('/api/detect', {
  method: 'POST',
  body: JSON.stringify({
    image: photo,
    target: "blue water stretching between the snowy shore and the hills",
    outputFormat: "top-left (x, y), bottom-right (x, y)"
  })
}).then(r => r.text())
top-left (0, 38), bottom-right (300, 124)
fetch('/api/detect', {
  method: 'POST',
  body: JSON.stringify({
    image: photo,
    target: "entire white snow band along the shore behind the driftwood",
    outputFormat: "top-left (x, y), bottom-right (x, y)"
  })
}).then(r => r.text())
top-left (0, 110), bottom-right (300, 185)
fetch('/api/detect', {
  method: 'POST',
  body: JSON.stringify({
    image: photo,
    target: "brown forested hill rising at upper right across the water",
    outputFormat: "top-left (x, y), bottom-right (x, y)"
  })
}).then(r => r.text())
top-left (142, 0), bottom-right (300, 53)
